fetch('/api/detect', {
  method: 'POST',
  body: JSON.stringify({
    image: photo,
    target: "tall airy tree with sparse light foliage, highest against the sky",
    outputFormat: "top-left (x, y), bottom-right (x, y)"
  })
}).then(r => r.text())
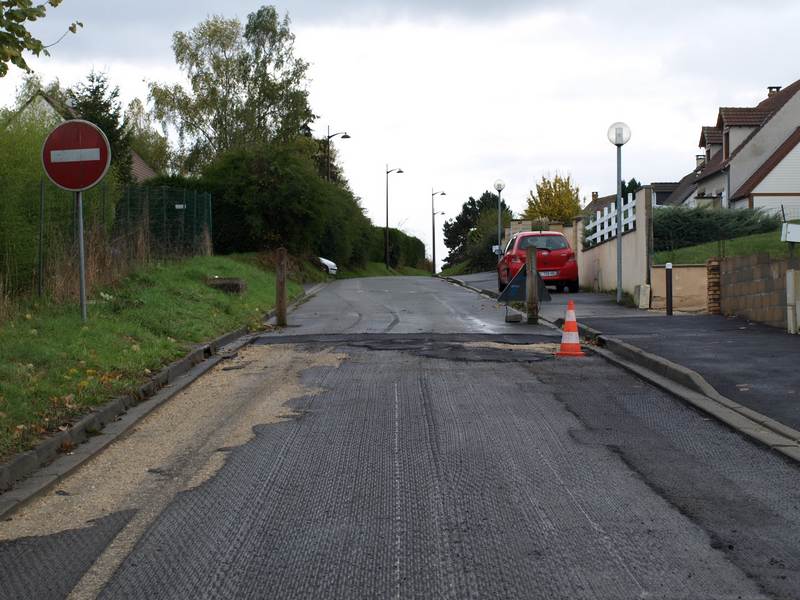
top-left (150, 6), bottom-right (314, 172)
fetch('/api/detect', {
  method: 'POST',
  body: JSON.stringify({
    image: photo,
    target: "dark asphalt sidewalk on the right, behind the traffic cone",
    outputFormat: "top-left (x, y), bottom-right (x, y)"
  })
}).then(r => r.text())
top-left (446, 272), bottom-right (800, 430)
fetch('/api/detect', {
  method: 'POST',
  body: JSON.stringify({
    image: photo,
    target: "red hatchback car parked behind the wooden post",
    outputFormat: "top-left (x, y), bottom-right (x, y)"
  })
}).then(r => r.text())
top-left (497, 231), bottom-right (580, 293)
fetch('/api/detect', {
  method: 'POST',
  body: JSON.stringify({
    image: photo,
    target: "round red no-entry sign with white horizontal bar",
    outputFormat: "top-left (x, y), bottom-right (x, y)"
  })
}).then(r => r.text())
top-left (42, 119), bottom-right (111, 192)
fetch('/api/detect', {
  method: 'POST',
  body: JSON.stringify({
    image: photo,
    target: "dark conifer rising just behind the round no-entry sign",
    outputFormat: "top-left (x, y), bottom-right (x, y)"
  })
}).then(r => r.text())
top-left (68, 71), bottom-right (132, 183)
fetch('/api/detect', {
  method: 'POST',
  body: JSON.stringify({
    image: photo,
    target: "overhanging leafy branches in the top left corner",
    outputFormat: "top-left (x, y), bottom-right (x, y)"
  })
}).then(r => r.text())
top-left (0, 0), bottom-right (83, 77)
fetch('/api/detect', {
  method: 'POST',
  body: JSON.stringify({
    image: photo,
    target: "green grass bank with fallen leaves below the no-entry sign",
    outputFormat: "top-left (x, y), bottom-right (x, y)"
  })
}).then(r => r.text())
top-left (0, 257), bottom-right (301, 458)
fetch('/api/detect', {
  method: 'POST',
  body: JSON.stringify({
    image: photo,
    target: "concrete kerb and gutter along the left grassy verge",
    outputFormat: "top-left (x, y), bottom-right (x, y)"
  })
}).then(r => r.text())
top-left (0, 283), bottom-right (326, 520)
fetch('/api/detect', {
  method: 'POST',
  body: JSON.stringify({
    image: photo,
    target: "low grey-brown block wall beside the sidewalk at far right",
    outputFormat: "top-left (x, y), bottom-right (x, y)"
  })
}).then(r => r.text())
top-left (720, 254), bottom-right (798, 328)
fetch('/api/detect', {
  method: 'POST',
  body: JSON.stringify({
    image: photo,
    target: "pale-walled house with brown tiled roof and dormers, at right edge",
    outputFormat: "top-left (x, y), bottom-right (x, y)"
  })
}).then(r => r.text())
top-left (666, 80), bottom-right (800, 217)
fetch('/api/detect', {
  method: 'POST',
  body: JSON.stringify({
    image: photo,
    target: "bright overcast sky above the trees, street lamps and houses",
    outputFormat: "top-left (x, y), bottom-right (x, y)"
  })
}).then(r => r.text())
top-left (0, 0), bottom-right (800, 268)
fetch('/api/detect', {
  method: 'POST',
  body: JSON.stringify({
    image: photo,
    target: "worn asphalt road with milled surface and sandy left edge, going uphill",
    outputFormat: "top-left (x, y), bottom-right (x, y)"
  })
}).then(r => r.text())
top-left (0, 278), bottom-right (800, 600)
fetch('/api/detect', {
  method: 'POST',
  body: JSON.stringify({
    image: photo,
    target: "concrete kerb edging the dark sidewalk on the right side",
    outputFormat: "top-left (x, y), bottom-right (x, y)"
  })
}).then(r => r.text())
top-left (443, 277), bottom-right (800, 462)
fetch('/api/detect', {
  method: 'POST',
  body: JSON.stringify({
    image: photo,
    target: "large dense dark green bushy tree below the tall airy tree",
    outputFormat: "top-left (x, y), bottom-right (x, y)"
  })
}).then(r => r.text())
top-left (202, 137), bottom-right (371, 265)
